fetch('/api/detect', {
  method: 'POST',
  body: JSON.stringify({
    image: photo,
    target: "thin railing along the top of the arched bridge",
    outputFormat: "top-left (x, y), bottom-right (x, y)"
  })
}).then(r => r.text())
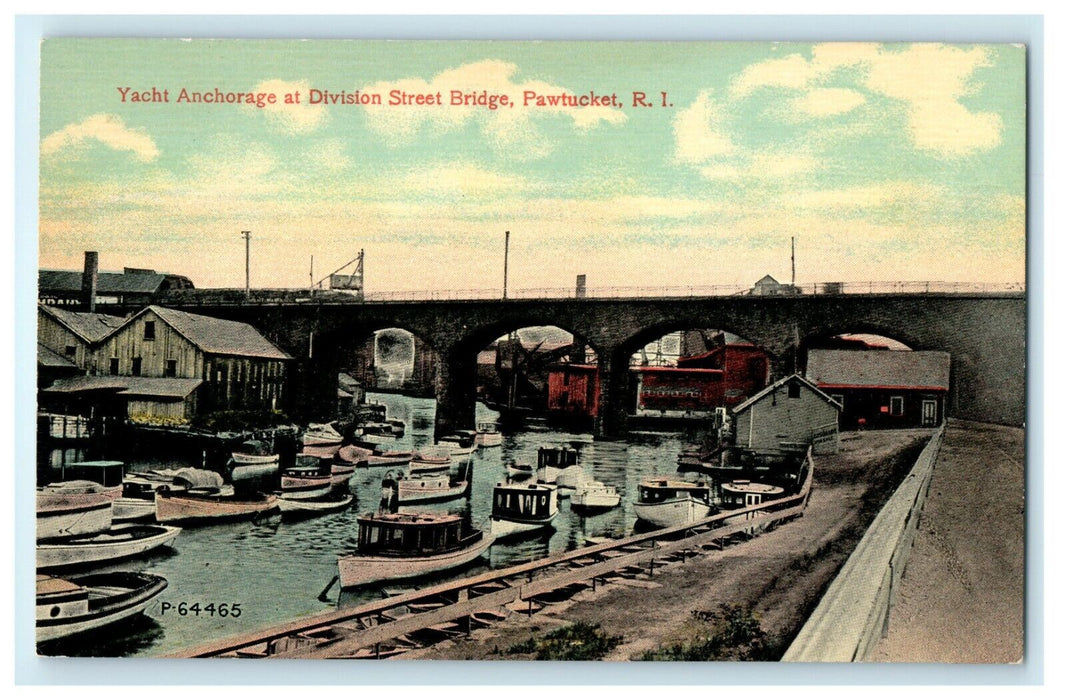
top-left (158, 280), bottom-right (1025, 306)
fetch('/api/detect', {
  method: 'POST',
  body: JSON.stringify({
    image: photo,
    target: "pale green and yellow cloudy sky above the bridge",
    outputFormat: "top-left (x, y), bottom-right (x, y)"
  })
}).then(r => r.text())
top-left (39, 38), bottom-right (1025, 293)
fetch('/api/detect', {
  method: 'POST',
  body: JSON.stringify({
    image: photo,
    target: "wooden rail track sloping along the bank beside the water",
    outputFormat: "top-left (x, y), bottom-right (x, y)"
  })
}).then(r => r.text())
top-left (168, 452), bottom-right (814, 658)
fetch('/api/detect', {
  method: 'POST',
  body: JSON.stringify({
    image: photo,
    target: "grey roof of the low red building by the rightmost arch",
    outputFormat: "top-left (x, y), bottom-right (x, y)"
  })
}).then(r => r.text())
top-left (807, 349), bottom-right (951, 390)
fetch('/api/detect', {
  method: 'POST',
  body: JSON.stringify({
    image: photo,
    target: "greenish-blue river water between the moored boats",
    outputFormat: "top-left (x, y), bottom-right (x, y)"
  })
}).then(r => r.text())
top-left (42, 393), bottom-right (682, 656)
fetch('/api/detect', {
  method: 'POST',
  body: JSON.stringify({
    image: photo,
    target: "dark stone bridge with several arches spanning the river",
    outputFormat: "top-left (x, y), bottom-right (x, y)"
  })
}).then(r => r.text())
top-left (135, 292), bottom-right (1027, 437)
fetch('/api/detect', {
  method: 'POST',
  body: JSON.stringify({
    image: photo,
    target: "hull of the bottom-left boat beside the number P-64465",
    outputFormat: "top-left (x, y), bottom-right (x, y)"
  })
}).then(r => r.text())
top-left (36, 573), bottom-right (166, 642)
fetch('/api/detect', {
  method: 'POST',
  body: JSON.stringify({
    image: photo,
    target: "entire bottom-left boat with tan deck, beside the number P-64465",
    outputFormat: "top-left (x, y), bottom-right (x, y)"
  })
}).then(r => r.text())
top-left (36, 571), bottom-right (166, 642)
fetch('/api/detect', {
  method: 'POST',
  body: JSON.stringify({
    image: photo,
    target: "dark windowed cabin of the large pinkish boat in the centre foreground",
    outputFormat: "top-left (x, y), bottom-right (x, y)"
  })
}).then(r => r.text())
top-left (358, 512), bottom-right (481, 556)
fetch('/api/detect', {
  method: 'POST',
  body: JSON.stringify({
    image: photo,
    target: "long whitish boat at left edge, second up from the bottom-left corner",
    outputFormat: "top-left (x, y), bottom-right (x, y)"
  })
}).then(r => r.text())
top-left (37, 525), bottom-right (181, 569)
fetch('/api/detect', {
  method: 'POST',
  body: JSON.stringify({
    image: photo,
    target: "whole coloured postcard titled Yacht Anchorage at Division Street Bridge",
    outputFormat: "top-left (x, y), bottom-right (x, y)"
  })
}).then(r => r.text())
top-left (33, 38), bottom-right (1027, 664)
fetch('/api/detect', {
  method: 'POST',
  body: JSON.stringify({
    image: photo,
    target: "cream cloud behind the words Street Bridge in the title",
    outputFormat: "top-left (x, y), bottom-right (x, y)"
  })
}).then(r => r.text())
top-left (359, 60), bottom-right (626, 158)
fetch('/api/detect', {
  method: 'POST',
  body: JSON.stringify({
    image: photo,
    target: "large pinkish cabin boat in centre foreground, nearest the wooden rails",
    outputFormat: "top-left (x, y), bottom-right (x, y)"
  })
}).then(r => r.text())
top-left (337, 512), bottom-right (496, 588)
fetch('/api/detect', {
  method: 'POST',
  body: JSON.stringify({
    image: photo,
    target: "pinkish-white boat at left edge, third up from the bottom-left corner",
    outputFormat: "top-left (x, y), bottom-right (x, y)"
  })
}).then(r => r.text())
top-left (37, 481), bottom-right (123, 540)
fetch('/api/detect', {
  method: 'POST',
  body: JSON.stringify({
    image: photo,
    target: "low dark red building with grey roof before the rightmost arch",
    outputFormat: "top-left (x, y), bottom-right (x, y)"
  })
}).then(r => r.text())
top-left (806, 348), bottom-right (951, 429)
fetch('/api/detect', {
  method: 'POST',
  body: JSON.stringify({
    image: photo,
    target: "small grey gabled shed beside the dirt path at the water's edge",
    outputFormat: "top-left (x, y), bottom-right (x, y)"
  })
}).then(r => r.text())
top-left (732, 374), bottom-right (840, 454)
